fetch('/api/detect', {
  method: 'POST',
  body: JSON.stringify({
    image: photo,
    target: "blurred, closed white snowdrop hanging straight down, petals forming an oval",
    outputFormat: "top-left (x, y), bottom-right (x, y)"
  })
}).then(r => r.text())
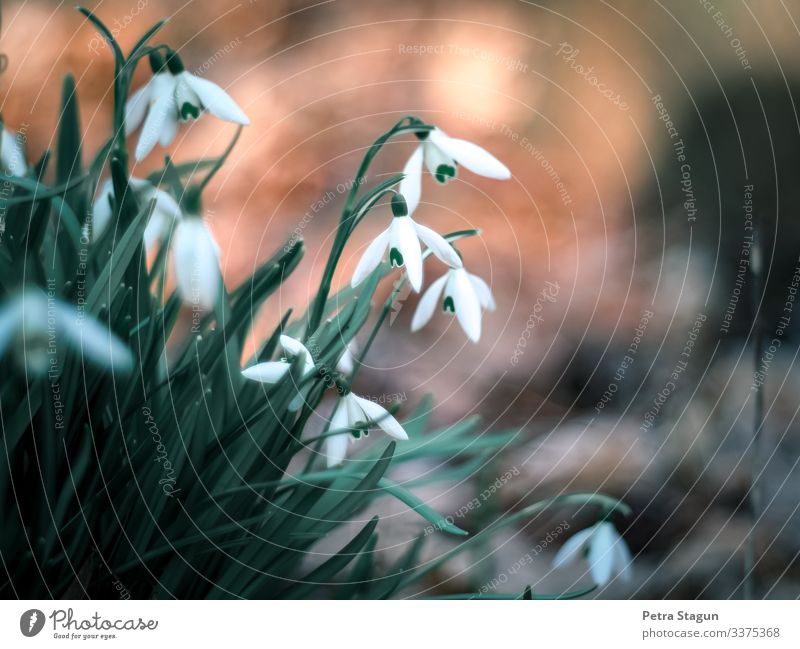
top-left (172, 215), bottom-right (222, 311)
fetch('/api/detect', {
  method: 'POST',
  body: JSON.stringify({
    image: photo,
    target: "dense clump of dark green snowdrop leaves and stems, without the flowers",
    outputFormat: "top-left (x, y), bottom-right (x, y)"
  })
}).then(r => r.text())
top-left (0, 10), bottom-right (624, 598)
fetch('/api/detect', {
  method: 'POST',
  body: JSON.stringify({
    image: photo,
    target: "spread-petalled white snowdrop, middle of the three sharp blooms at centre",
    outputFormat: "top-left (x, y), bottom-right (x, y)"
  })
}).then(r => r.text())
top-left (350, 194), bottom-right (462, 293)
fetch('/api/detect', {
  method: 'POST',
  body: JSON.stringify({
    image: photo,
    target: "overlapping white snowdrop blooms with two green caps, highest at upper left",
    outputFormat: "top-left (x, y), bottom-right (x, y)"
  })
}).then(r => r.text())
top-left (125, 50), bottom-right (250, 161)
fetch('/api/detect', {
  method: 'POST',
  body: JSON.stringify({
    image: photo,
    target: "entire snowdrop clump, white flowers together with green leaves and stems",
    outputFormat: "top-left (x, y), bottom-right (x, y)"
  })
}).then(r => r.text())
top-left (0, 9), bottom-right (627, 598)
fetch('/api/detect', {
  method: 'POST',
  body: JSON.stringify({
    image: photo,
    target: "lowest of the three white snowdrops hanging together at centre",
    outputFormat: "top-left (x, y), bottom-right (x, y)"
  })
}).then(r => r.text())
top-left (411, 268), bottom-right (495, 343)
